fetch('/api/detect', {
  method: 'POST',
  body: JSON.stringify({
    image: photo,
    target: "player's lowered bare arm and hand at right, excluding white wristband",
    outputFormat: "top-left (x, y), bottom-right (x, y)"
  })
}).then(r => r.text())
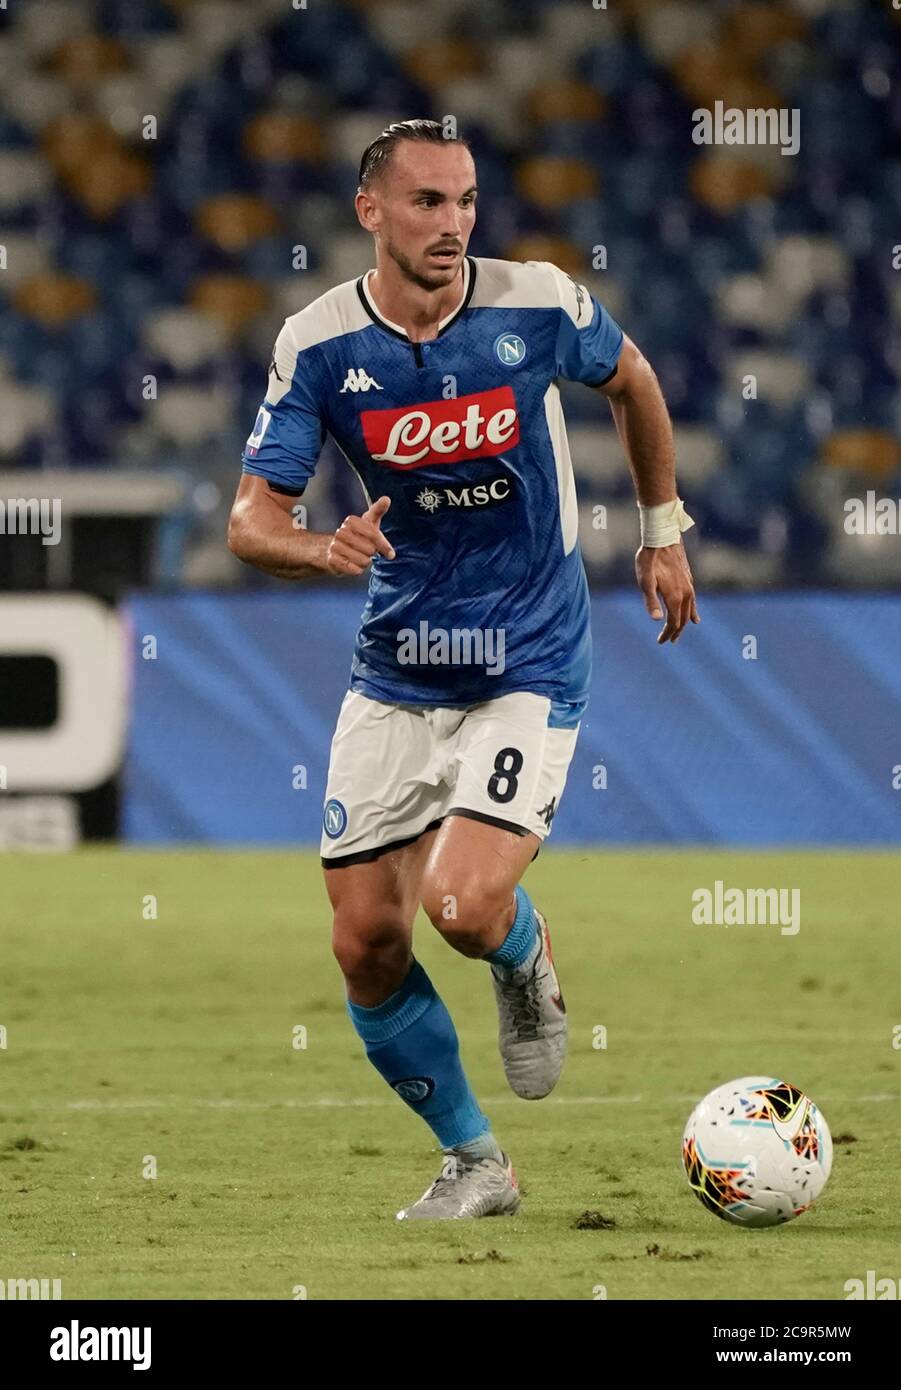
top-left (596, 338), bottom-right (701, 642)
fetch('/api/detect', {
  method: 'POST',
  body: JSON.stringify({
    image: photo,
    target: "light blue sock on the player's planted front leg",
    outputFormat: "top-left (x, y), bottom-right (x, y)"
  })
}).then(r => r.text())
top-left (348, 960), bottom-right (491, 1148)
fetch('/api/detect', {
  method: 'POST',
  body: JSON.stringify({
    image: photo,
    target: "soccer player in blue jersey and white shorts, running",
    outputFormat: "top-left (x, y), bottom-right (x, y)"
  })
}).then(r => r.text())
top-left (229, 121), bottom-right (698, 1219)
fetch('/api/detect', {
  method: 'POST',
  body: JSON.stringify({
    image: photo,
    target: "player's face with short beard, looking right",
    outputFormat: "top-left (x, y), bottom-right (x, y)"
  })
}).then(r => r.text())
top-left (370, 140), bottom-right (476, 289)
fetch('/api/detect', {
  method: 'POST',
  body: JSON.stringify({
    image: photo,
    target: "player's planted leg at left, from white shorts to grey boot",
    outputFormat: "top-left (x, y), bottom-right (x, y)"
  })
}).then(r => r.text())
top-left (323, 696), bottom-right (519, 1218)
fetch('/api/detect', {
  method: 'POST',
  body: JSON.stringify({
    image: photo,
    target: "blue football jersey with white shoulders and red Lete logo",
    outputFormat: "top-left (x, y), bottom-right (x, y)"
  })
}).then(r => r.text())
top-left (242, 257), bottom-right (623, 723)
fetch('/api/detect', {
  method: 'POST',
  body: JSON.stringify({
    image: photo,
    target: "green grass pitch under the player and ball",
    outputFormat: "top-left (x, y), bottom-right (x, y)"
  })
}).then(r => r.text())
top-left (0, 849), bottom-right (901, 1300)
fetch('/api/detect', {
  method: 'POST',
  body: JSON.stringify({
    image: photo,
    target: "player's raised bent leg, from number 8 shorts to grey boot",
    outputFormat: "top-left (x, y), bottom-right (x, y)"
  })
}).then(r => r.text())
top-left (423, 692), bottom-right (578, 1099)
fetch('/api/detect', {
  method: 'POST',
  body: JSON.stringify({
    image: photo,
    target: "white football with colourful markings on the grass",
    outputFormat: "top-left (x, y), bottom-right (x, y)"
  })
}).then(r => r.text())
top-left (683, 1076), bottom-right (831, 1227)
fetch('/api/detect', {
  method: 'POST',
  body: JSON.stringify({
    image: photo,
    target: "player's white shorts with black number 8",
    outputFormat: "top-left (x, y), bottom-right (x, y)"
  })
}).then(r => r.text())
top-left (321, 691), bottom-right (578, 867)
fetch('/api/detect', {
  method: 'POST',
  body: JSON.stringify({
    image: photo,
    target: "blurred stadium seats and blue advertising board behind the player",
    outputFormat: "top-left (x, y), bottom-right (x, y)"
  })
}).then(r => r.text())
top-left (0, 0), bottom-right (901, 848)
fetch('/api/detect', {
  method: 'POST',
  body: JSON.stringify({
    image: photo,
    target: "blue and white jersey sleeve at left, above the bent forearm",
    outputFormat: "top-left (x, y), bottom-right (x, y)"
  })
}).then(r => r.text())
top-left (241, 321), bottom-right (325, 496)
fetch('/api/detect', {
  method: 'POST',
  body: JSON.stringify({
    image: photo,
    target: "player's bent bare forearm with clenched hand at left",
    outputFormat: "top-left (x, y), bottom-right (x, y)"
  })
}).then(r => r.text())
top-left (228, 473), bottom-right (395, 580)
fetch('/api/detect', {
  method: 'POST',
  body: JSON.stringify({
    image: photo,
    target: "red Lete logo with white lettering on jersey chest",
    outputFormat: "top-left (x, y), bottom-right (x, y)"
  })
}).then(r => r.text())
top-left (360, 386), bottom-right (520, 468)
